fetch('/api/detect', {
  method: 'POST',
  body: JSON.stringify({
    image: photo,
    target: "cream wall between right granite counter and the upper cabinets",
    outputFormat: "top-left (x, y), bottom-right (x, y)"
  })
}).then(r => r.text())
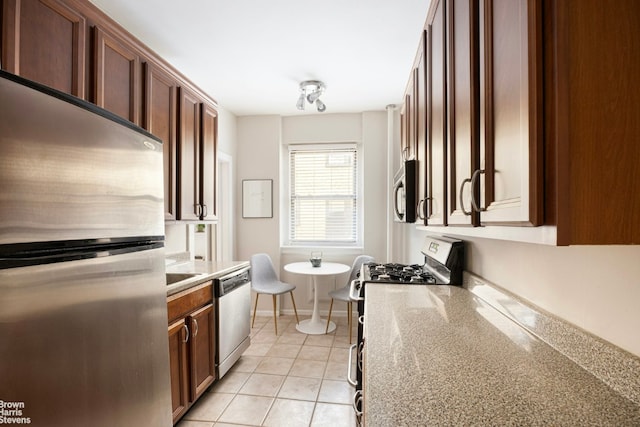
top-left (407, 229), bottom-right (640, 356)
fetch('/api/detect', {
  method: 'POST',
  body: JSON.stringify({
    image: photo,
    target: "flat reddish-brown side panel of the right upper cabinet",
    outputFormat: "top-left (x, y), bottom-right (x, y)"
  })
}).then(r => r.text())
top-left (544, 0), bottom-right (640, 245)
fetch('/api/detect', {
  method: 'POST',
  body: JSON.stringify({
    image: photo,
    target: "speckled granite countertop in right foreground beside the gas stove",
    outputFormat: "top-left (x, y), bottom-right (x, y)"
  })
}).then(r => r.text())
top-left (364, 283), bottom-right (640, 427)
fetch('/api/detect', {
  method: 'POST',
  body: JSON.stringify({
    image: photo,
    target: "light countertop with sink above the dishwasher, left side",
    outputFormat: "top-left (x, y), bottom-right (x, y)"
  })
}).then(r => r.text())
top-left (166, 261), bottom-right (249, 296)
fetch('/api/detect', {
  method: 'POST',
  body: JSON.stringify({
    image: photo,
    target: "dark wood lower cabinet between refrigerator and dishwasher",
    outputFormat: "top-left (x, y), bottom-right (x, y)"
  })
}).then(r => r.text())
top-left (167, 282), bottom-right (216, 423)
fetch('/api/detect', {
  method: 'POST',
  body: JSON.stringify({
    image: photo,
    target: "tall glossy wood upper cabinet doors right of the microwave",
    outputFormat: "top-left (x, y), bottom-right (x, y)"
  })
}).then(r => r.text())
top-left (419, 0), bottom-right (544, 226)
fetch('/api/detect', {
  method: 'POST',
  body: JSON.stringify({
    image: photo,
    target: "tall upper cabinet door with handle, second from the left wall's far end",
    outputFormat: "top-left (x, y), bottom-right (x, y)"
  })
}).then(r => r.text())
top-left (177, 87), bottom-right (201, 220)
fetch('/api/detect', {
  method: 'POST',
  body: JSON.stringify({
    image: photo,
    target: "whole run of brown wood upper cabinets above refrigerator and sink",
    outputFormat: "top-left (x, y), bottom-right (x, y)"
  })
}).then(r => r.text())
top-left (0, 0), bottom-right (218, 227)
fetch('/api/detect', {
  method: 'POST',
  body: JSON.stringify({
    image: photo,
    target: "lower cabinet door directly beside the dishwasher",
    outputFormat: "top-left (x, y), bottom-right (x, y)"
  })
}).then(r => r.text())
top-left (188, 304), bottom-right (216, 402)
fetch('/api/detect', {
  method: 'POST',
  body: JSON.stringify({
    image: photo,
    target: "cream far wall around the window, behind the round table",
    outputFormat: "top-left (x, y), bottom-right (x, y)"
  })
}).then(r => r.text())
top-left (236, 111), bottom-right (387, 313)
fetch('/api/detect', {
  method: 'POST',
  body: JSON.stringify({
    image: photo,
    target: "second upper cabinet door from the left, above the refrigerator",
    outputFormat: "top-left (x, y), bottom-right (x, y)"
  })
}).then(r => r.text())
top-left (93, 26), bottom-right (140, 125)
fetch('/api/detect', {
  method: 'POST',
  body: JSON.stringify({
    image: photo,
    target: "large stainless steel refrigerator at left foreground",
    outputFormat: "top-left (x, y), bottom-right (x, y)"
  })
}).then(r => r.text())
top-left (0, 71), bottom-right (172, 427)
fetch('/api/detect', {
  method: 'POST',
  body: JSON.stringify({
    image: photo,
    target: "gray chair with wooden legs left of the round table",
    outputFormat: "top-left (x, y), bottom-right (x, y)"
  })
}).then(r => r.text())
top-left (249, 254), bottom-right (300, 335)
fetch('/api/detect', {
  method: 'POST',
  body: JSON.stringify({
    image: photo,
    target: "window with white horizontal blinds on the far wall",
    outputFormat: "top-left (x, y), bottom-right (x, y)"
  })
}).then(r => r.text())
top-left (289, 145), bottom-right (358, 245)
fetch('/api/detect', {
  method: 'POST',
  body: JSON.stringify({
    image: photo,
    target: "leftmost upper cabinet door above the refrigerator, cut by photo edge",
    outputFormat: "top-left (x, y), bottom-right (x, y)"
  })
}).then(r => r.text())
top-left (0, 0), bottom-right (86, 98)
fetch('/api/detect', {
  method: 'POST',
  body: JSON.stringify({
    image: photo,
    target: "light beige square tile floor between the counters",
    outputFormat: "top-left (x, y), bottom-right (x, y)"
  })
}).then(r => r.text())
top-left (177, 316), bottom-right (356, 427)
